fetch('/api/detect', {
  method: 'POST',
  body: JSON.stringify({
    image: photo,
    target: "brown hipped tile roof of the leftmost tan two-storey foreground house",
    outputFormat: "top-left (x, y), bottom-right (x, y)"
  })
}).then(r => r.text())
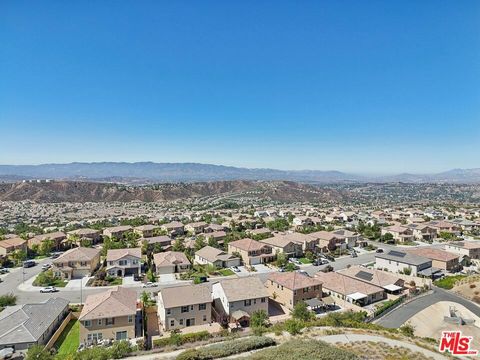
top-left (78, 286), bottom-right (137, 321)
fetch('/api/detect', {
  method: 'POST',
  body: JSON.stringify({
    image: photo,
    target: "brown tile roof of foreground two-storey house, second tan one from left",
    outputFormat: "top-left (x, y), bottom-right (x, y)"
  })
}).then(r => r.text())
top-left (158, 284), bottom-right (212, 309)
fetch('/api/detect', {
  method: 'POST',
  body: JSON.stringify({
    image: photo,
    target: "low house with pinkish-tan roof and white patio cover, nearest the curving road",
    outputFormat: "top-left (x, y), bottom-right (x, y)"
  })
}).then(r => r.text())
top-left (315, 271), bottom-right (386, 306)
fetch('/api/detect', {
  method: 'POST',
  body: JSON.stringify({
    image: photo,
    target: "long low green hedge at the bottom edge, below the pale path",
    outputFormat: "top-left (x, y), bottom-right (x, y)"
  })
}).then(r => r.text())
top-left (177, 336), bottom-right (276, 360)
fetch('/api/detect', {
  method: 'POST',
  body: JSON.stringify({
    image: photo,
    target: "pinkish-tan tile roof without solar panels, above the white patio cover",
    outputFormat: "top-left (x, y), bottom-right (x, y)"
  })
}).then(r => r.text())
top-left (315, 271), bottom-right (384, 295)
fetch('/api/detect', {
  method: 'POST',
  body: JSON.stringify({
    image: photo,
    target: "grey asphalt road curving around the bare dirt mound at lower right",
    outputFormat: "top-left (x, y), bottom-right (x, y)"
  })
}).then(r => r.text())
top-left (376, 287), bottom-right (480, 329)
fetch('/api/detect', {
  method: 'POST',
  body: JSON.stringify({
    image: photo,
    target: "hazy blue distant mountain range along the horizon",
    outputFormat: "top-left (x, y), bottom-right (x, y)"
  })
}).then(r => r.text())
top-left (0, 162), bottom-right (480, 184)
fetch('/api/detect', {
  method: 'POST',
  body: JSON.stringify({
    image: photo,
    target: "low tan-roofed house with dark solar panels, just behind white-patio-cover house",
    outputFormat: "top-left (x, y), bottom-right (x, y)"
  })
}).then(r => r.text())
top-left (339, 265), bottom-right (405, 294)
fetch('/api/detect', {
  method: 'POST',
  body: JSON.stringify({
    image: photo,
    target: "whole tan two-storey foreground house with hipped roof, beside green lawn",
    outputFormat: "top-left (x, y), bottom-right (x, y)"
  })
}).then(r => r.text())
top-left (78, 286), bottom-right (137, 345)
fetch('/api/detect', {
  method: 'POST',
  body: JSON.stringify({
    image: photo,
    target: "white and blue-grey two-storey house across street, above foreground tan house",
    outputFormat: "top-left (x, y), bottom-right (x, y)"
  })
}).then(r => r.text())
top-left (106, 248), bottom-right (142, 277)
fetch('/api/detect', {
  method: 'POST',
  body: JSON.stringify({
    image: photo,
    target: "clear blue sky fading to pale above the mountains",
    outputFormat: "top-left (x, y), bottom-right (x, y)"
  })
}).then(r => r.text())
top-left (0, 0), bottom-right (480, 173)
